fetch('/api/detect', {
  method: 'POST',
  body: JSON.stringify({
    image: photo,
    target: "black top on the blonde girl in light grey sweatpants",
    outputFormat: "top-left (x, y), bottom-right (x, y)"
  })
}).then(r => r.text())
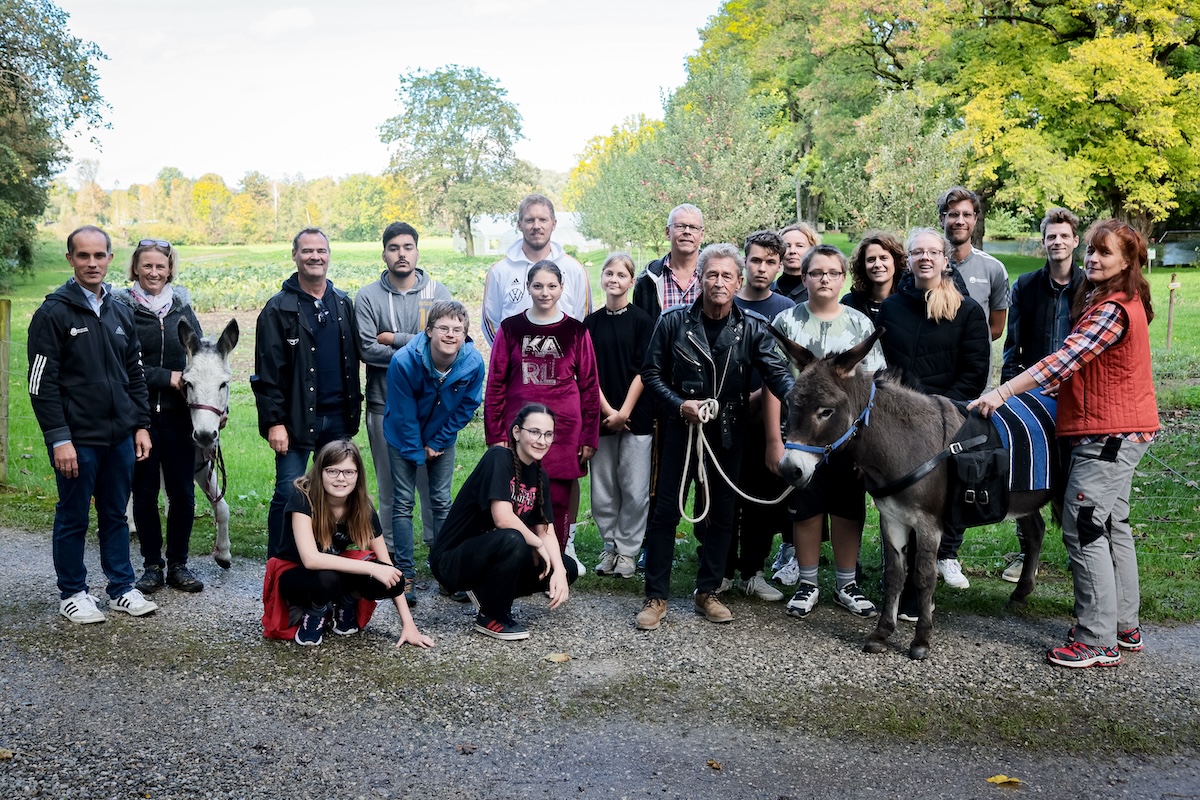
top-left (583, 303), bottom-right (654, 437)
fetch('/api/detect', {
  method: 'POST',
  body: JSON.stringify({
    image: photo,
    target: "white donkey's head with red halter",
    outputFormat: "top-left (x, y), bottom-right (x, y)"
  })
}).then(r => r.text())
top-left (179, 319), bottom-right (238, 459)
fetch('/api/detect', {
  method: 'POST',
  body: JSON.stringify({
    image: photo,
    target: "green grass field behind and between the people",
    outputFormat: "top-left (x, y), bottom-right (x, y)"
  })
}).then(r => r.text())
top-left (0, 234), bottom-right (1200, 620)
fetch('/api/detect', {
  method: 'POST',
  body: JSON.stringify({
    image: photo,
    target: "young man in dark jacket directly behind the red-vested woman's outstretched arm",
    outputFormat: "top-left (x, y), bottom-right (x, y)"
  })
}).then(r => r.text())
top-left (1000, 207), bottom-right (1084, 583)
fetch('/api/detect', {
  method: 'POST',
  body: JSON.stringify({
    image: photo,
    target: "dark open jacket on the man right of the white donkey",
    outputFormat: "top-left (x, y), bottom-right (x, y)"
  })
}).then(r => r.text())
top-left (250, 272), bottom-right (362, 450)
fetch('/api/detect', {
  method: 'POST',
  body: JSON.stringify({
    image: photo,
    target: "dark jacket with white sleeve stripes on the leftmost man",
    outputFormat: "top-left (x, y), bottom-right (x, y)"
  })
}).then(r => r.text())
top-left (28, 279), bottom-right (150, 447)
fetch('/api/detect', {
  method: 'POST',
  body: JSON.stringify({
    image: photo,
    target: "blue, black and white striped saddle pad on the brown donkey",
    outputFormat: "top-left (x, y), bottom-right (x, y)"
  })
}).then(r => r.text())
top-left (991, 389), bottom-right (1058, 492)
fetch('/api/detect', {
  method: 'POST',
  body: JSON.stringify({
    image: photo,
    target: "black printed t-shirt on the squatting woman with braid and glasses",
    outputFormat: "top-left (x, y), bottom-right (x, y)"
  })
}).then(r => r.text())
top-left (430, 445), bottom-right (554, 560)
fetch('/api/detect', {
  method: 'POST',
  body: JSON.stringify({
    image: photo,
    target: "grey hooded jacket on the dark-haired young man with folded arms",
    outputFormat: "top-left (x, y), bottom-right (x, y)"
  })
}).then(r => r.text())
top-left (354, 267), bottom-right (450, 414)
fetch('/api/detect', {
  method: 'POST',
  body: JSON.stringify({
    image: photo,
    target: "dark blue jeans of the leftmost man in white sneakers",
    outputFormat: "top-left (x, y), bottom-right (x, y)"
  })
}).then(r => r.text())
top-left (49, 435), bottom-right (136, 600)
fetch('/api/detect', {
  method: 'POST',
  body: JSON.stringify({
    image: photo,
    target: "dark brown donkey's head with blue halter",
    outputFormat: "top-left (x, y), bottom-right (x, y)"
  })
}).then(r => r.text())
top-left (769, 329), bottom-right (882, 488)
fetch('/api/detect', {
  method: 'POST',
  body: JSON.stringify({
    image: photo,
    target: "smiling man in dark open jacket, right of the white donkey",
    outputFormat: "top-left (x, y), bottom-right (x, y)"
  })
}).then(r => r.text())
top-left (250, 228), bottom-right (362, 554)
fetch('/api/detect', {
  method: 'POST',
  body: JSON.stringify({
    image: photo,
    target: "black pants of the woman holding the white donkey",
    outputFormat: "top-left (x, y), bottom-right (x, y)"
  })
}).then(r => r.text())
top-left (133, 411), bottom-right (196, 567)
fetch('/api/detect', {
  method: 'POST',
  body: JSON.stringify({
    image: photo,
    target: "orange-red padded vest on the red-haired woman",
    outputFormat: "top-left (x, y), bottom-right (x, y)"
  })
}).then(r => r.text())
top-left (1058, 295), bottom-right (1159, 437)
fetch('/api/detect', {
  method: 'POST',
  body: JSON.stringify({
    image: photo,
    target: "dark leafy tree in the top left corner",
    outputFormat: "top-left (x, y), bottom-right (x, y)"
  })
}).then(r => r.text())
top-left (0, 0), bottom-right (104, 275)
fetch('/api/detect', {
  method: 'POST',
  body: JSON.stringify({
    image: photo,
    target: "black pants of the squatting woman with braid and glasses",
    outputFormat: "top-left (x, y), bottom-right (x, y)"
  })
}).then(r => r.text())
top-left (430, 528), bottom-right (580, 620)
